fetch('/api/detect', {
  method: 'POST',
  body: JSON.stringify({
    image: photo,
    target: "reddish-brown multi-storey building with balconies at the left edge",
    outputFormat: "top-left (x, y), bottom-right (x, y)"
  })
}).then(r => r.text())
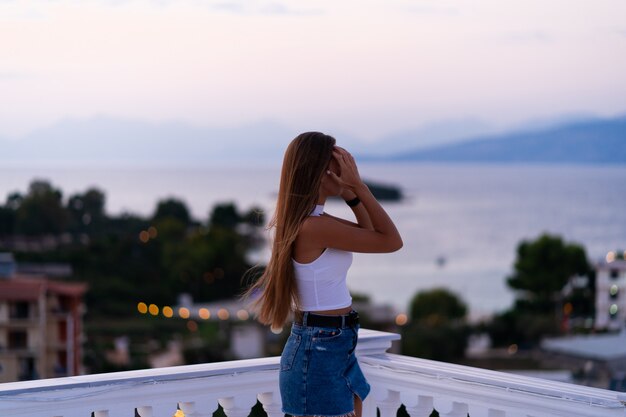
top-left (0, 253), bottom-right (87, 383)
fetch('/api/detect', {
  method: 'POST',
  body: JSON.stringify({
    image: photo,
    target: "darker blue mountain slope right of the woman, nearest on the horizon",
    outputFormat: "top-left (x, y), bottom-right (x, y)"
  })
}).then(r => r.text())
top-left (384, 117), bottom-right (626, 164)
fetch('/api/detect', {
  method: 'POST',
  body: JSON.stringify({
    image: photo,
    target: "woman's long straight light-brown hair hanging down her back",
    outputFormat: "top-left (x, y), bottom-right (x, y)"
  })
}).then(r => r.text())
top-left (246, 132), bottom-right (335, 328)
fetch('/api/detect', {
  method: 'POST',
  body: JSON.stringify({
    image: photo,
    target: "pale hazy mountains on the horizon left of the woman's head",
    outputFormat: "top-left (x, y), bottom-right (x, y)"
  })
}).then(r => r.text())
top-left (0, 116), bottom-right (295, 167)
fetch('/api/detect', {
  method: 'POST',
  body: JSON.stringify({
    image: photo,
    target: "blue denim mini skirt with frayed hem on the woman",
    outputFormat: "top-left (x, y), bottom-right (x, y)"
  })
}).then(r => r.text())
top-left (279, 323), bottom-right (370, 417)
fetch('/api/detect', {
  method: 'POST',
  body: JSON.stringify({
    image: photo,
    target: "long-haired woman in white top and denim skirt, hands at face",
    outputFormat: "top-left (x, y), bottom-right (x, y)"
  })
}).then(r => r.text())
top-left (246, 132), bottom-right (402, 417)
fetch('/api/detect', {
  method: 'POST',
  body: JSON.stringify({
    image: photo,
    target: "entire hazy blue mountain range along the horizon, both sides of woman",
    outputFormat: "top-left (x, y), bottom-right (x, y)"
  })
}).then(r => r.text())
top-left (0, 116), bottom-right (626, 167)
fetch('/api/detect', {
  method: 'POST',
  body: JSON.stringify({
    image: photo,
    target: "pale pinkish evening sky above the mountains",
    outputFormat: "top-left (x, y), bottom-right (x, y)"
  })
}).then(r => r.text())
top-left (0, 0), bottom-right (626, 140)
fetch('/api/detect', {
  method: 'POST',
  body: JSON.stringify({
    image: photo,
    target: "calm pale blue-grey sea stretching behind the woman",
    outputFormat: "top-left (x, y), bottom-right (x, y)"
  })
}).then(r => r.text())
top-left (0, 163), bottom-right (626, 320)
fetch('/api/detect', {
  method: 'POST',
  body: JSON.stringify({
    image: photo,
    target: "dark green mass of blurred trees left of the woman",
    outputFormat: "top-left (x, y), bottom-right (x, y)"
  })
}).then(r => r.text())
top-left (0, 181), bottom-right (264, 371)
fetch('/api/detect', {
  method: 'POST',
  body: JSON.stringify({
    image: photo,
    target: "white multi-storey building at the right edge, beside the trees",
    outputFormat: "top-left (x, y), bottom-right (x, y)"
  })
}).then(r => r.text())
top-left (595, 252), bottom-right (626, 330)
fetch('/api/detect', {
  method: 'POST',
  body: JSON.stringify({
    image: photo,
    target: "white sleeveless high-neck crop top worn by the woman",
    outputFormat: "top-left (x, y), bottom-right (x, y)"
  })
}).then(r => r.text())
top-left (292, 205), bottom-right (352, 311)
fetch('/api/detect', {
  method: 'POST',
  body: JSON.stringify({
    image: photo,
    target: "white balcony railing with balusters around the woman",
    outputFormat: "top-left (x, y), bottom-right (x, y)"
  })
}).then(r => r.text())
top-left (0, 329), bottom-right (626, 417)
